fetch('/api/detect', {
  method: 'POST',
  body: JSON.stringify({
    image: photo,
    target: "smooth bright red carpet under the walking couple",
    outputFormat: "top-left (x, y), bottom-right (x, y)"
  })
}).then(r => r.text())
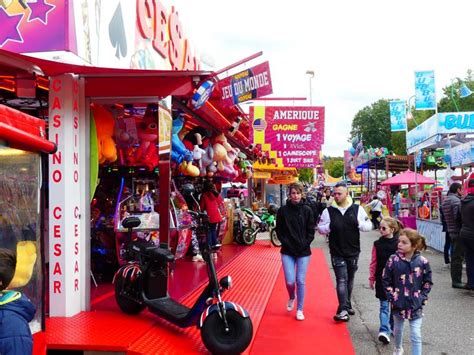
top-left (250, 249), bottom-right (355, 355)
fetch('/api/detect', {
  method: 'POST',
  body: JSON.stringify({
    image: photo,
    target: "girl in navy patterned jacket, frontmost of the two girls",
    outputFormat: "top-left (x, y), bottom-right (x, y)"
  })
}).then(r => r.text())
top-left (382, 228), bottom-right (433, 355)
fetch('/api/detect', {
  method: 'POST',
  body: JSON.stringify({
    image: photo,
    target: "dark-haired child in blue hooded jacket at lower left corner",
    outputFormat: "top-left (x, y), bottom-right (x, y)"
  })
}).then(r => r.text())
top-left (0, 248), bottom-right (36, 355)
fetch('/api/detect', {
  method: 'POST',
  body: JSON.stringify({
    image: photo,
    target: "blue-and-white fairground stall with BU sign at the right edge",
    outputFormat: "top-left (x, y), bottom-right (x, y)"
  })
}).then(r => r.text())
top-left (407, 112), bottom-right (474, 251)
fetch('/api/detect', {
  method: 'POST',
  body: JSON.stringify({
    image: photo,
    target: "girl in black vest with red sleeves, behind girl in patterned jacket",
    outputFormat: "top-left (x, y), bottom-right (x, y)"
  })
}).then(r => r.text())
top-left (369, 217), bottom-right (401, 344)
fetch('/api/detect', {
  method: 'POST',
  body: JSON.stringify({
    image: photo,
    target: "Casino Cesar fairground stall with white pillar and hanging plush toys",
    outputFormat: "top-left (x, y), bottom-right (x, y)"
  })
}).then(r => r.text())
top-left (0, 1), bottom-right (262, 350)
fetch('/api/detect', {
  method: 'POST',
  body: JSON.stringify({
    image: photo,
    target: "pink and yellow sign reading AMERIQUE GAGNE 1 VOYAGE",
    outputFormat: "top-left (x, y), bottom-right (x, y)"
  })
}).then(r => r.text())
top-left (250, 106), bottom-right (324, 168)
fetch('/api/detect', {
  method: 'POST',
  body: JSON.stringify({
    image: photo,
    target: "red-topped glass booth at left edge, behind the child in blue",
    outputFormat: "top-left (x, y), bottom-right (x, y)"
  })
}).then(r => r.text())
top-left (0, 102), bottom-right (56, 353)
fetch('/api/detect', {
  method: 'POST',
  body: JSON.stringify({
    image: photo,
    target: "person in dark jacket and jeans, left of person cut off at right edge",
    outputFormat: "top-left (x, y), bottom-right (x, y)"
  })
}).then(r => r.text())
top-left (441, 182), bottom-right (466, 288)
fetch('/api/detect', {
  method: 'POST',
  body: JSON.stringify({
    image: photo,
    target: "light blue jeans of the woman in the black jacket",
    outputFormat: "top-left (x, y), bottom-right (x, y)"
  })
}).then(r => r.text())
top-left (281, 254), bottom-right (311, 311)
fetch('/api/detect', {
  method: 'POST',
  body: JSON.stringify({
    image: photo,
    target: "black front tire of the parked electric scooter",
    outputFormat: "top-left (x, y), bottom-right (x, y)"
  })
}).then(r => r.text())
top-left (201, 309), bottom-right (253, 355)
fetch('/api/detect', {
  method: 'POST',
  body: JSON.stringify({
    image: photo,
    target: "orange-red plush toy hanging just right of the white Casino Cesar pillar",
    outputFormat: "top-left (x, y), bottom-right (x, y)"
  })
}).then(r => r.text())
top-left (91, 104), bottom-right (117, 164)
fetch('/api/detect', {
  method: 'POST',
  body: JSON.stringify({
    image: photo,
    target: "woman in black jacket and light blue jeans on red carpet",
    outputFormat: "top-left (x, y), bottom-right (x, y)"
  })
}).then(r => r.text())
top-left (276, 183), bottom-right (315, 320)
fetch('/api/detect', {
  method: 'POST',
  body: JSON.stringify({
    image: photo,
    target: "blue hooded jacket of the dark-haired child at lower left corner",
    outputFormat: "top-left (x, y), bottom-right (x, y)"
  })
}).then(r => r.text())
top-left (0, 291), bottom-right (36, 355)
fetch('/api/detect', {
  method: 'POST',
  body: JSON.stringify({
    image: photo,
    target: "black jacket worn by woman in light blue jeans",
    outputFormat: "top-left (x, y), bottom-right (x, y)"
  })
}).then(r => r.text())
top-left (276, 200), bottom-right (315, 257)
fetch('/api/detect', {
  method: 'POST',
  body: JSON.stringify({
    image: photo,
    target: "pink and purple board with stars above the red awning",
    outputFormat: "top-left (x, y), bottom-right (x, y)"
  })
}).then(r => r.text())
top-left (0, 0), bottom-right (76, 53)
